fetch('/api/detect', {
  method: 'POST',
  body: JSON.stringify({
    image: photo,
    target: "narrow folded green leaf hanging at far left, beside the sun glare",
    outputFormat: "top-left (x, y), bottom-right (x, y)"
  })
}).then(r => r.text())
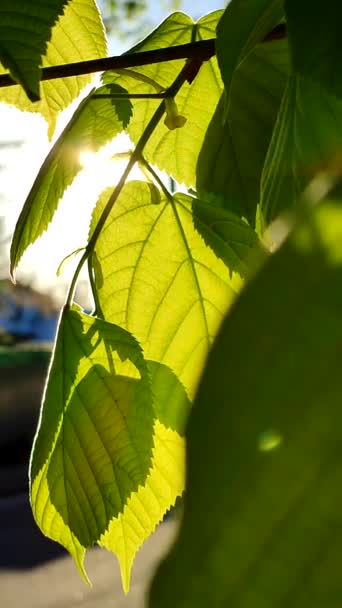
top-left (11, 85), bottom-right (132, 274)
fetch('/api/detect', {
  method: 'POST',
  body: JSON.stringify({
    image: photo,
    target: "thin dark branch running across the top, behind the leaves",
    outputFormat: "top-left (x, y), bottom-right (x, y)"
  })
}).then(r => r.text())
top-left (0, 24), bottom-right (287, 88)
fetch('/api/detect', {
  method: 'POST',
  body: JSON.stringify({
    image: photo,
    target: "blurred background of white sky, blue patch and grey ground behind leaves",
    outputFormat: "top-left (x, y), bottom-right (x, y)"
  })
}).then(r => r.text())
top-left (0, 0), bottom-right (225, 608)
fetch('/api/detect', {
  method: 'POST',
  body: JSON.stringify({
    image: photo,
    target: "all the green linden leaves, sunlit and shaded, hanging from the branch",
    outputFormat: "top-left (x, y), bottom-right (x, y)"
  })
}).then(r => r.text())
top-left (0, 0), bottom-right (342, 608)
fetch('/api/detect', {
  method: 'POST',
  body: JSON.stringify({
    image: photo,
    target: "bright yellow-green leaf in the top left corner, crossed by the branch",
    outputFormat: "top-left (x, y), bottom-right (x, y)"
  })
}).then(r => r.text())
top-left (0, 0), bottom-right (107, 137)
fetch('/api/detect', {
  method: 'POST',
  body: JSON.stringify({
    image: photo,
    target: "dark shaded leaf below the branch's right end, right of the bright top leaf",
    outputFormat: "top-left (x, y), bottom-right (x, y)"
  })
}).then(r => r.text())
top-left (196, 39), bottom-right (288, 225)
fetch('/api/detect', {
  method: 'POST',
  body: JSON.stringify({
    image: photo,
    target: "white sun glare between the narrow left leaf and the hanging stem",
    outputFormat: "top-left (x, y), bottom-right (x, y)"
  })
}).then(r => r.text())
top-left (10, 135), bottom-right (146, 292)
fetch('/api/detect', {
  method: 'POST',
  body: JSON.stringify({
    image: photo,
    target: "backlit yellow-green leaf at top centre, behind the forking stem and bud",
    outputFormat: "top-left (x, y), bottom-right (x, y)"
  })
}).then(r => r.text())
top-left (104, 11), bottom-right (223, 186)
